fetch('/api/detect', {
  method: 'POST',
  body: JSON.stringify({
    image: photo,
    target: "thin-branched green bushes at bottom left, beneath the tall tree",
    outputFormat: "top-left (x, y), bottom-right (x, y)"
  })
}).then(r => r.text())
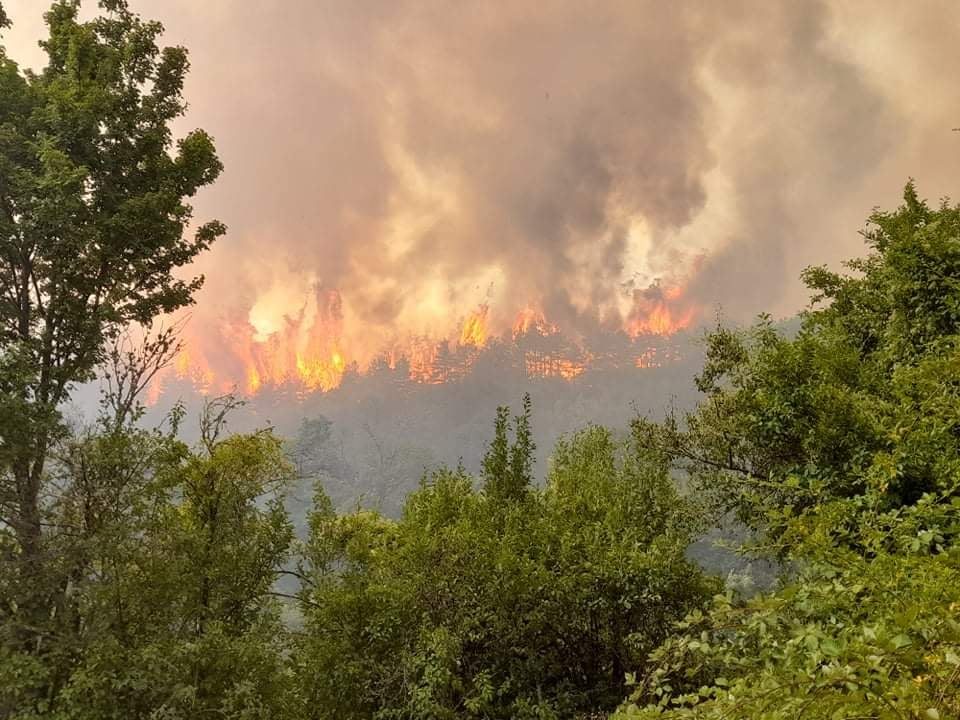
top-left (0, 399), bottom-right (293, 719)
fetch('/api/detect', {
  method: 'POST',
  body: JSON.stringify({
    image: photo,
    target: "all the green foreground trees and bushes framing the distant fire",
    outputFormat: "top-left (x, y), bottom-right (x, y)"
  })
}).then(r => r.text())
top-left (0, 0), bottom-right (960, 720)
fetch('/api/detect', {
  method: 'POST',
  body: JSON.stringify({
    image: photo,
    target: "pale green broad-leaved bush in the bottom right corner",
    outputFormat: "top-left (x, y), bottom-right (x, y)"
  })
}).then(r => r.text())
top-left (618, 501), bottom-right (960, 719)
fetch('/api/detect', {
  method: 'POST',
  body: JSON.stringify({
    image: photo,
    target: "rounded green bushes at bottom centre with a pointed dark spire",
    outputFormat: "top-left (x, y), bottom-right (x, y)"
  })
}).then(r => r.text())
top-left (296, 408), bottom-right (715, 718)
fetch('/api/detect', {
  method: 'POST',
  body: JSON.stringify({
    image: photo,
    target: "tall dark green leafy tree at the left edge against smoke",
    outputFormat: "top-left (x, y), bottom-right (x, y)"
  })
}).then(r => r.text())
top-left (0, 0), bottom-right (225, 640)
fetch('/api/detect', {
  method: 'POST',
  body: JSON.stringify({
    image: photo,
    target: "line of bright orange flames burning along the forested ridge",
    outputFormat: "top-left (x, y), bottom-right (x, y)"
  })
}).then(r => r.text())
top-left (150, 285), bottom-right (700, 400)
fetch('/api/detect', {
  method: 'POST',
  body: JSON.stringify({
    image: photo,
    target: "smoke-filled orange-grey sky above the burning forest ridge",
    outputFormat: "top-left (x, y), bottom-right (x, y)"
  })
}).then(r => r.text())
top-left (4, 0), bottom-right (960, 358)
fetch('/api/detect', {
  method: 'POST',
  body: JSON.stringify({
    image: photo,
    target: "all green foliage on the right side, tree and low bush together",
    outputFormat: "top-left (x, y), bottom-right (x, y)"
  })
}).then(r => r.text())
top-left (618, 185), bottom-right (960, 719)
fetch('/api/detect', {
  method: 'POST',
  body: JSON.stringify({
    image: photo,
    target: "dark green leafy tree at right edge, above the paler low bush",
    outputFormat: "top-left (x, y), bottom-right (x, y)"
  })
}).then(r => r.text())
top-left (634, 185), bottom-right (960, 527)
